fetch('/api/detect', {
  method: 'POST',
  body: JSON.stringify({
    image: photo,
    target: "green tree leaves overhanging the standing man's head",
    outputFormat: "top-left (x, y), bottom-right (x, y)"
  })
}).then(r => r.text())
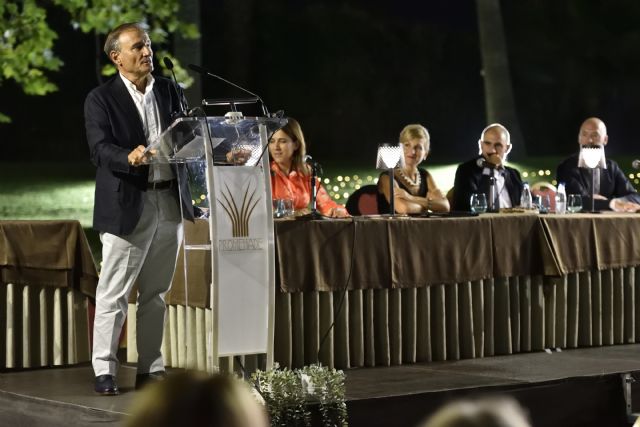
top-left (0, 0), bottom-right (200, 123)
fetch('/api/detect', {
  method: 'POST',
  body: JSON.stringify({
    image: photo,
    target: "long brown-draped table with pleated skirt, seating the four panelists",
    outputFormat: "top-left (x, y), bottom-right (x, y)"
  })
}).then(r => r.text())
top-left (139, 213), bottom-right (640, 368)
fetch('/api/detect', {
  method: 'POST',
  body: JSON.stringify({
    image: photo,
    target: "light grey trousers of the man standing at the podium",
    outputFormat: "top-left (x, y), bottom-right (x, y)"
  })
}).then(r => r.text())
top-left (91, 189), bottom-right (183, 376)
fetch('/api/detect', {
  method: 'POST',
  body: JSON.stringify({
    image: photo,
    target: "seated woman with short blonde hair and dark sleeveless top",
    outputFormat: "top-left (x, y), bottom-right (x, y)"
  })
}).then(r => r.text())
top-left (378, 124), bottom-right (449, 214)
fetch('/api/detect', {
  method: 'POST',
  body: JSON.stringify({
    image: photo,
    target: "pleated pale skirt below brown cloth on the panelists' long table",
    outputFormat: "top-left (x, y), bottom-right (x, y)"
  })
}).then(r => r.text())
top-left (127, 267), bottom-right (640, 371)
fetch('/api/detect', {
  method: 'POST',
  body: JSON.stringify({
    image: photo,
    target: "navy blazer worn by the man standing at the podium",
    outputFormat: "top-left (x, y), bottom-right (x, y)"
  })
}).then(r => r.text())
top-left (84, 74), bottom-right (193, 235)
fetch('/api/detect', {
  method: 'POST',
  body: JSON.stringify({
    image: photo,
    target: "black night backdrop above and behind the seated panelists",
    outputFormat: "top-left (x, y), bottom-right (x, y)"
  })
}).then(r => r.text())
top-left (0, 0), bottom-right (640, 165)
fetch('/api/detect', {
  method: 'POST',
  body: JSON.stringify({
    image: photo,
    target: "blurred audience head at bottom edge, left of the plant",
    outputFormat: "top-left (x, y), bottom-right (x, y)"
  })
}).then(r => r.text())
top-left (126, 373), bottom-right (269, 427)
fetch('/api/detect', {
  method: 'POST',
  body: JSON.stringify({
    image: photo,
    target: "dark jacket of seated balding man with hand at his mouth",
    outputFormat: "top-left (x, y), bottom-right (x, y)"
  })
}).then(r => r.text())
top-left (451, 156), bottom-right (522, 211)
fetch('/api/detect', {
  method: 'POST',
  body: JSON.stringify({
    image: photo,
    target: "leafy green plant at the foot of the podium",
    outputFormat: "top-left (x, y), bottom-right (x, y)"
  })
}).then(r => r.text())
top-left (251, 365), bottom-right (348, 427)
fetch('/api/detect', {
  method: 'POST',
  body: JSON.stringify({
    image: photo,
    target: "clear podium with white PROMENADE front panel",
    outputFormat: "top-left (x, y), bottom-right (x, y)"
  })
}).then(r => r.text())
top-left (147, 113), bottom-right (287, 370)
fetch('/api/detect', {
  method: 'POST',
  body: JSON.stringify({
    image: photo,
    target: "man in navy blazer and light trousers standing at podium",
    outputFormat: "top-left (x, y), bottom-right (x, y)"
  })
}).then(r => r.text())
top-left (84, 23), bottom-right (192, 395)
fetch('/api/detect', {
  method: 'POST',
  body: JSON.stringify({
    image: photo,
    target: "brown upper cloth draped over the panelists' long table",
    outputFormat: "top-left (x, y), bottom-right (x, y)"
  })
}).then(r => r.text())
top-left (167, 213), bottom-right (640, 307)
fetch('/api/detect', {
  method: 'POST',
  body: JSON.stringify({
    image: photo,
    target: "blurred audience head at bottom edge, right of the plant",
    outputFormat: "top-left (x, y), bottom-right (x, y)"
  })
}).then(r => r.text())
top-left (420, 397), bottom-right (531, 427)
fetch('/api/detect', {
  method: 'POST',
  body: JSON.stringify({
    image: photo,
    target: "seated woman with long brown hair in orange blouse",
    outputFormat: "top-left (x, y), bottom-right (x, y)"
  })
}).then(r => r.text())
top-left (269, 117), bottom-right (349, 218)
